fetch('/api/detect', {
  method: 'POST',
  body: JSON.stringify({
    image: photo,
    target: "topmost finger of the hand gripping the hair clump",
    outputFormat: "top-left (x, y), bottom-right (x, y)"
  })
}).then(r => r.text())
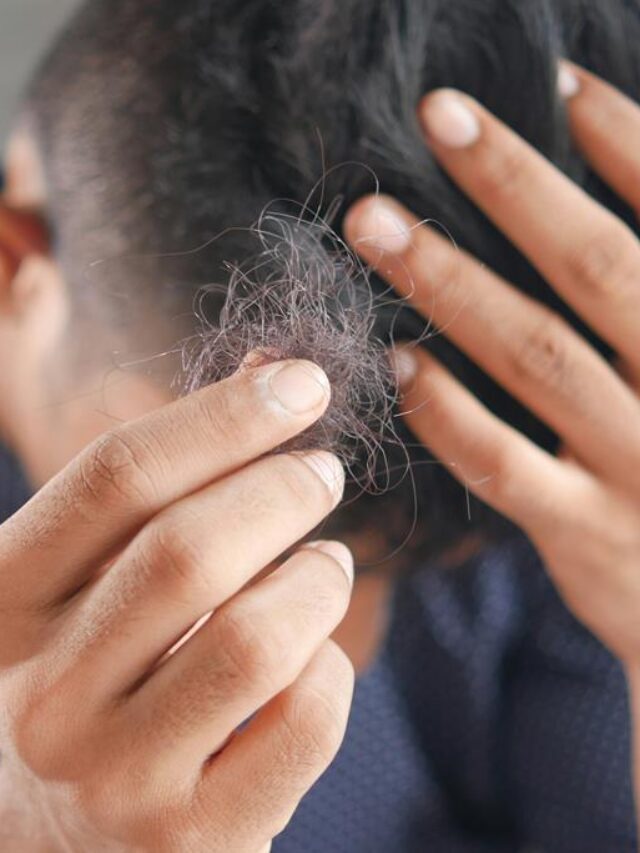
top-left (0, 361), bottom-right (330, 607)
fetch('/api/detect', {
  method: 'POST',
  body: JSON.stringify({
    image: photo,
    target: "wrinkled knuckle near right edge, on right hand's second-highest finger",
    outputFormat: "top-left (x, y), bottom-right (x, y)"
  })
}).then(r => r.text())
top-left (568, 223), bottom-right (640, 302)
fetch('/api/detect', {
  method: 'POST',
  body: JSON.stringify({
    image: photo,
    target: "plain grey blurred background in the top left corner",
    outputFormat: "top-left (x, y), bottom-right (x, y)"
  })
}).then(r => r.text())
top-left (0, 0), bottom-right (79, 147)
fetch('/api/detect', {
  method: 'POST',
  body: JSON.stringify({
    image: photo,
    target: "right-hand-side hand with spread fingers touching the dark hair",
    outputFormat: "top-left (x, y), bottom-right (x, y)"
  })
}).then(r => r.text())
top-left (345, 63), bottom-right (640, 670)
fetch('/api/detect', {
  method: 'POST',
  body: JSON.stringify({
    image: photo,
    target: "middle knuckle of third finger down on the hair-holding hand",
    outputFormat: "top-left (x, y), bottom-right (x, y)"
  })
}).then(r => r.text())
top-left (217, 604), bottom-right (288, 693)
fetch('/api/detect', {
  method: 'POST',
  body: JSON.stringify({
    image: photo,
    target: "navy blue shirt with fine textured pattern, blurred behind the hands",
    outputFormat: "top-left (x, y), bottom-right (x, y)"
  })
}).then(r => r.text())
top-left (0, 442), bottom-right (637, 853)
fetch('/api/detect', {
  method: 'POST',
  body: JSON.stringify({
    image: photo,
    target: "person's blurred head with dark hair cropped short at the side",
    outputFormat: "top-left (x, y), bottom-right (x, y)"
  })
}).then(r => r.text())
top-left (0, 0), bottom-right (640, 564)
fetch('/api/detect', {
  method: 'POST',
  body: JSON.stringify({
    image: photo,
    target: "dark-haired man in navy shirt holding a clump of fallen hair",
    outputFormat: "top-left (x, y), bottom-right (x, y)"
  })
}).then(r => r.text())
top-left (0, 0), bottom-right (638, 853)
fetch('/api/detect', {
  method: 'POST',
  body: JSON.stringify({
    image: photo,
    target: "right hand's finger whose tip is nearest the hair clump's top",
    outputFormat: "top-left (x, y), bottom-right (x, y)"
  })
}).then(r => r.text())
top-left (345, 198), bottom-right (640, 485)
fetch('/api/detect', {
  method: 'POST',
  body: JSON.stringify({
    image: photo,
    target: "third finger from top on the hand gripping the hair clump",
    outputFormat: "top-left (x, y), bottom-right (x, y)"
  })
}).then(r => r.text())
top-left (127, 542), bottom-right (353, 775)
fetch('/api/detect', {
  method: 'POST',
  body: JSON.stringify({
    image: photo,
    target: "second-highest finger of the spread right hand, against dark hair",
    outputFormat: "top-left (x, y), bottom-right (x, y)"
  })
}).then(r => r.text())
top-left (421, 90), bottom-right (640, 366)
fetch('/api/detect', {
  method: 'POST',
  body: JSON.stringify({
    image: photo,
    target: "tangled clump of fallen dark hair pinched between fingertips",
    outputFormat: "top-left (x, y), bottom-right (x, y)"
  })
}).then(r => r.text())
top-left (184, 211), bottom-right (396, 491)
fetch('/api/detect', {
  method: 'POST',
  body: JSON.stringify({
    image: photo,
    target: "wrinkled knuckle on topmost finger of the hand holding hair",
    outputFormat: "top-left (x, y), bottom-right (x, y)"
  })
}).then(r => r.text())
top-left (80, 430), bottom-right (153, 506)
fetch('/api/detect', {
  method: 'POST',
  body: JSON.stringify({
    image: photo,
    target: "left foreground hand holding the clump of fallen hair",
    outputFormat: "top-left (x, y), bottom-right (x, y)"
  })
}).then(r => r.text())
top-left (0, 362), bottom-right (353, 853)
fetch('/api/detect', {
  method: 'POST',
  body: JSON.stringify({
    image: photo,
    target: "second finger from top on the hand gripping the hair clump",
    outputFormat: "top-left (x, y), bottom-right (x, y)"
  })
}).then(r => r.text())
top-left (55, 452), bottom-right (344, 702)
